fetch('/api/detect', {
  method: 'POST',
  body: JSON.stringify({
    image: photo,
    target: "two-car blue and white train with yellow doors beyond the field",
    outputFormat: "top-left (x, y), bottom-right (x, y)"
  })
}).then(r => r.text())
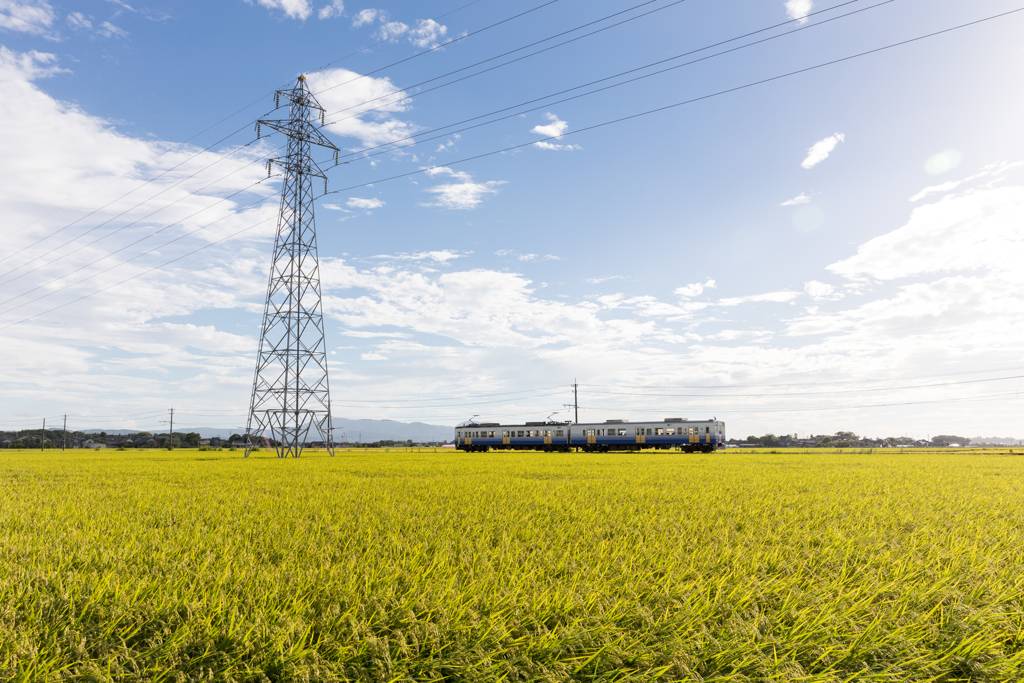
top-left (455, 418), bottom-right (725, 453)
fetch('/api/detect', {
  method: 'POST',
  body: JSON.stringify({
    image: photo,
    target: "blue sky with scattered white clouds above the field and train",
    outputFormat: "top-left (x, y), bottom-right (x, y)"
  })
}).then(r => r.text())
top-left (0, 0), bottom-right (1024, 436)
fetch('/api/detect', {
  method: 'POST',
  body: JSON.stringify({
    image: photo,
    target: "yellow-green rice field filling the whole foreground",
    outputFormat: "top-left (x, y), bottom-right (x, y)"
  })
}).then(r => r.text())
top-left (0, 449), bottom-right (1024, 683)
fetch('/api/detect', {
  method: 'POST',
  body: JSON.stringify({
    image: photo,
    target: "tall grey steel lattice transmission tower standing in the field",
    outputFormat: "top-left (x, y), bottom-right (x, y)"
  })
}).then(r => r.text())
top-left (246, 76), bottom-right (338, 458)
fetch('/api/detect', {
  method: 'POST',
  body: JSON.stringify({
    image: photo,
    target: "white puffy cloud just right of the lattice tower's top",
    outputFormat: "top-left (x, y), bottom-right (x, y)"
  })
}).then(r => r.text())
top-left (307, 69), bottom-right (418, 146)
